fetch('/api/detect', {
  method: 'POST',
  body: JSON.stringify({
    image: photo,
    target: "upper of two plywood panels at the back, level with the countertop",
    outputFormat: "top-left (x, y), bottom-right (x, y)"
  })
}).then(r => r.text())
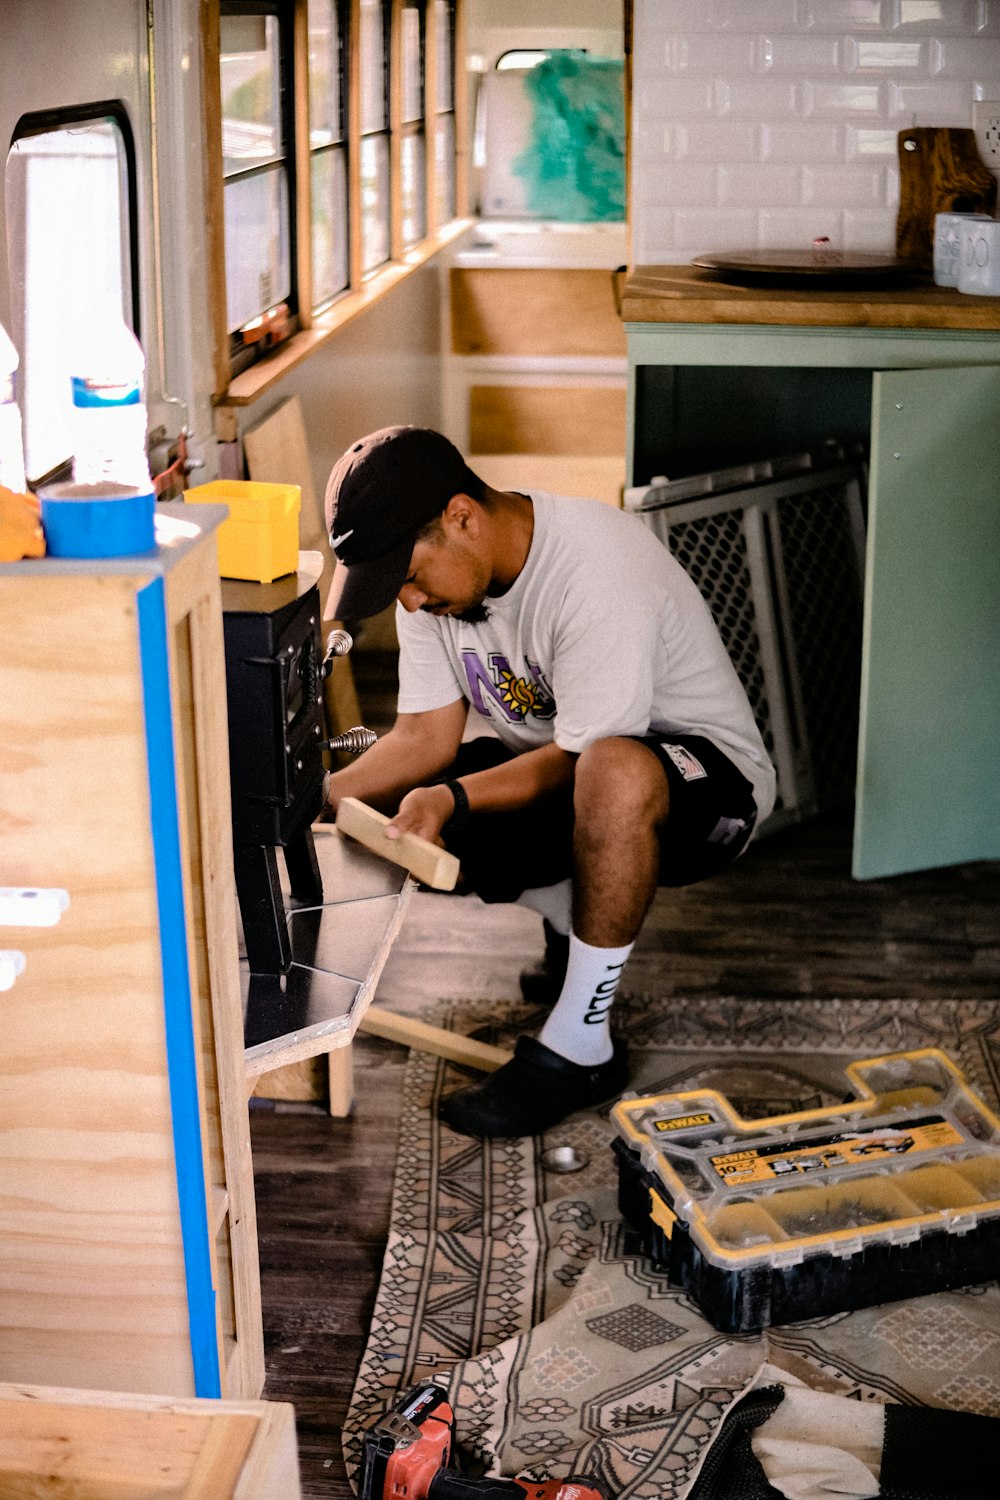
top-left (450, 266), bottom-right (625, 359)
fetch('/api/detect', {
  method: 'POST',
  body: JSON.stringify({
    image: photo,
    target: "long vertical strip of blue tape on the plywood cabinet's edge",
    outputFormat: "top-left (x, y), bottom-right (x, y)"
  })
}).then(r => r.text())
top-left (138, 578), bottom-right (222, 1397)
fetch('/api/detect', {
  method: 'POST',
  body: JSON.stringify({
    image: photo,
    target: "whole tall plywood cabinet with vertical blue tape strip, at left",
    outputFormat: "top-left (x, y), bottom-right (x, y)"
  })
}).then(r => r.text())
top-left (0, 506), bottom-right (264, 1398)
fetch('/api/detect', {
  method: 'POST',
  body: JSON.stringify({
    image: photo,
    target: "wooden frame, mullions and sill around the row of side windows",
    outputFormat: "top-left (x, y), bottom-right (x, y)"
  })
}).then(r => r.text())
top-left (202, 0), bottom-right (471, 407)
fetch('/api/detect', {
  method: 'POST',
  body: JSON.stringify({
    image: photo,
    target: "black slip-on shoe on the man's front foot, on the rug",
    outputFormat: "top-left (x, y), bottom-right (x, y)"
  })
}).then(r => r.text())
top-left (438, 1037), bottom-right (628, 1137)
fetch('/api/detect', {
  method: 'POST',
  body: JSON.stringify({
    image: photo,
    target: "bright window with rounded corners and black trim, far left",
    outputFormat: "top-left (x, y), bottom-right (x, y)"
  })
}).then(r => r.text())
top-left (4, 104), bottom-right (139, 485)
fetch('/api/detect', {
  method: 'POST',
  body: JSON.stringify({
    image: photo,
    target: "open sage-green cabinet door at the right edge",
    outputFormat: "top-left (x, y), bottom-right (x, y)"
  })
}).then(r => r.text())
top-left (853, 366), bottom-right (1000, 879)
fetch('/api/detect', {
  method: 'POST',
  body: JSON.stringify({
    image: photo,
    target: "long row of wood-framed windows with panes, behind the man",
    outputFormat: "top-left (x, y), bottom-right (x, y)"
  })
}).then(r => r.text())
top-left (205, 0), bottom-right (466, 402)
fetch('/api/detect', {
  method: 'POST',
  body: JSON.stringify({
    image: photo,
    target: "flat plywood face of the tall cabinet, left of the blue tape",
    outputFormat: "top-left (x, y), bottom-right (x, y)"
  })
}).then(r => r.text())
top-left (0, 576), bottom-right (193, 1392)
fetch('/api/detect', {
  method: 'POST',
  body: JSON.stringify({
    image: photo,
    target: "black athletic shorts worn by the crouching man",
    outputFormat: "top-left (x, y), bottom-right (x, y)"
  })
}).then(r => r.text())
top-left (441, 735), bottom-right (757, 902)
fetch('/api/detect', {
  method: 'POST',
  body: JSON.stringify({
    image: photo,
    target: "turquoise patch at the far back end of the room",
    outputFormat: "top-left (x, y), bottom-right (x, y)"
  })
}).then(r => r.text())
top-left (511, 51), bottom-right (625, 224)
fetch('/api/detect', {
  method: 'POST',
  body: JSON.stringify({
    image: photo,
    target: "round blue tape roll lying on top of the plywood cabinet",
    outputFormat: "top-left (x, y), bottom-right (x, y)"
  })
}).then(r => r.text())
top-left (39, 485), bottom-right (156, 558)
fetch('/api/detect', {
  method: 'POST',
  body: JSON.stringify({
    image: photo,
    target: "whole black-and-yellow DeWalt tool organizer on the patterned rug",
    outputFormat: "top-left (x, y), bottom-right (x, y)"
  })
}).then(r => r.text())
top-left (612, 1049), bottom-right (1000, 1332)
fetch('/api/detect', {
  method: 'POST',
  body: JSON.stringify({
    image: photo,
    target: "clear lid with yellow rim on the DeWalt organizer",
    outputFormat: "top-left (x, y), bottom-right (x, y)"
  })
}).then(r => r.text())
top-left (612, 1049), bottom-right (1000, 1265)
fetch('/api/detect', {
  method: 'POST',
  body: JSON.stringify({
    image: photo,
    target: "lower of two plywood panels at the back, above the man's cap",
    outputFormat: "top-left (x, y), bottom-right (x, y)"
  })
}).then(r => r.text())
top-left (469, 386), bottom-right (625, 456)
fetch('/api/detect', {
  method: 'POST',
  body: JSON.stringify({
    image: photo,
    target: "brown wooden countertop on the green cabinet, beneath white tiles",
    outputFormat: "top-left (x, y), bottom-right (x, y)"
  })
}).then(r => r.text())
top-left (622, 266), bottom-right (1000, 333)
